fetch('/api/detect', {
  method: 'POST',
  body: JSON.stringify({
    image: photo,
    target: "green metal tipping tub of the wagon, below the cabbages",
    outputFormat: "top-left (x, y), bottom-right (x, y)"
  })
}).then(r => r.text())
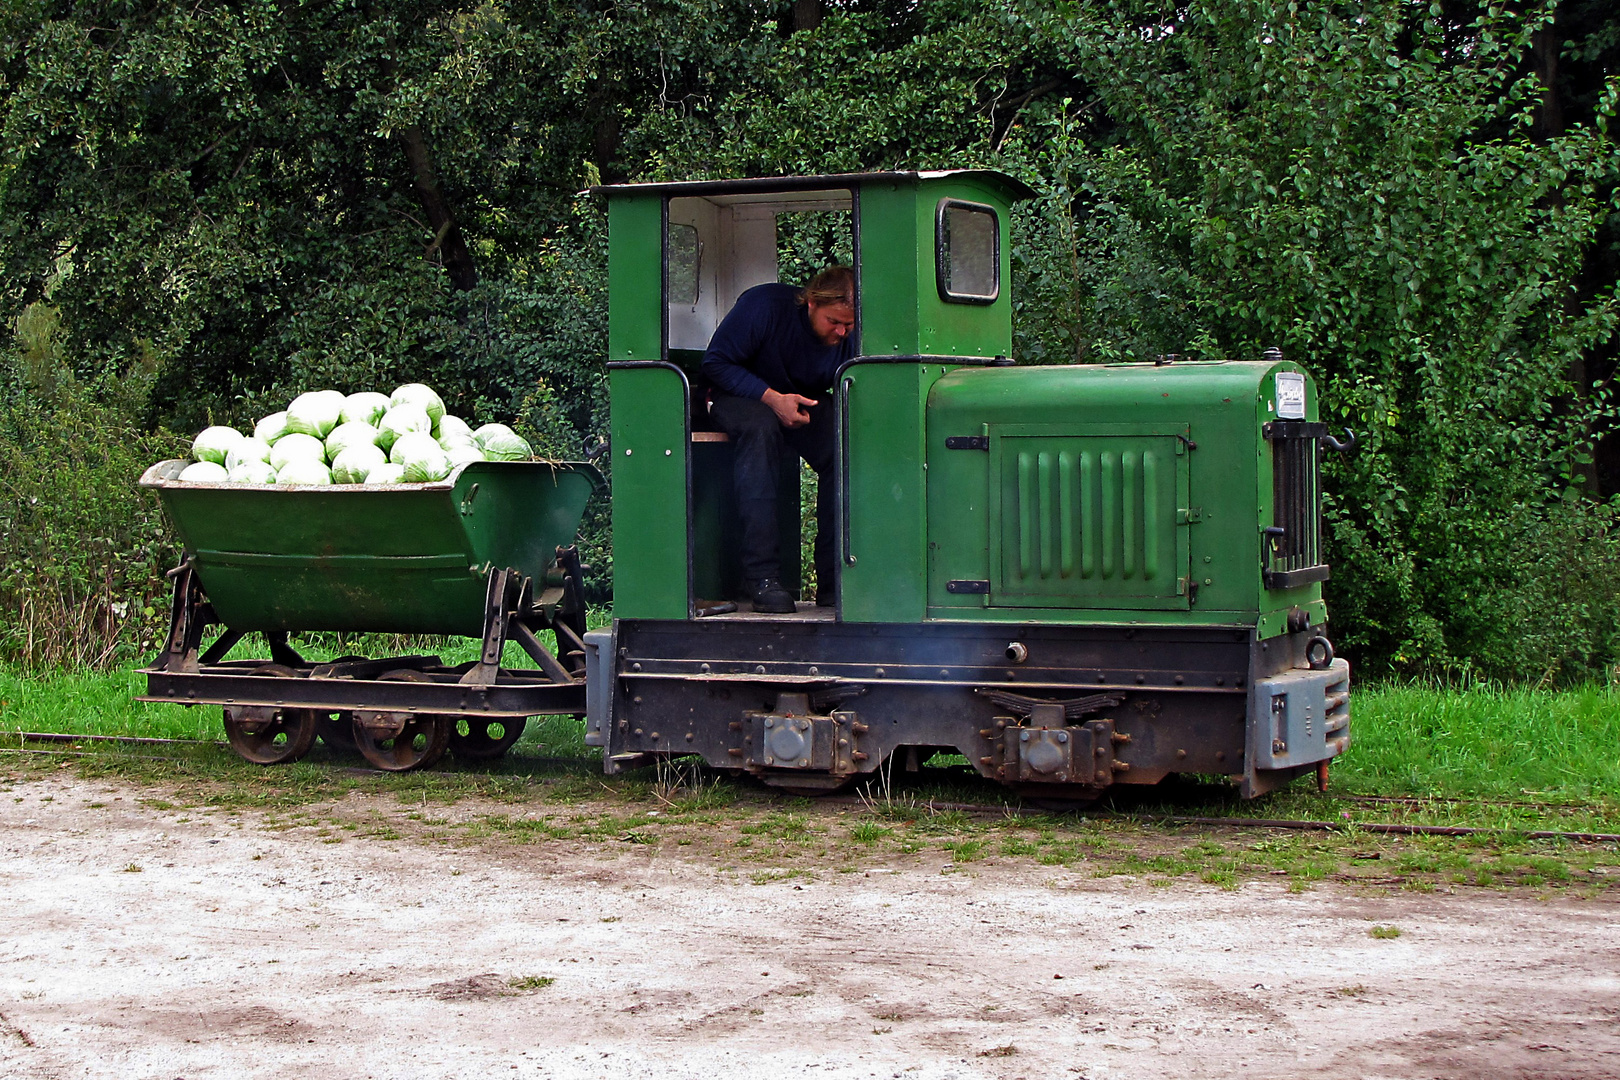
top-left (141, 461), bottom-right (601, 636)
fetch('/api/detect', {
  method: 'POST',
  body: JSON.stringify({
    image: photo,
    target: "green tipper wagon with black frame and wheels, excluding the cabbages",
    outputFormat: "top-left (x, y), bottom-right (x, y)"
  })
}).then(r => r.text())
top-left (141, 461), bottom-right (601, 771)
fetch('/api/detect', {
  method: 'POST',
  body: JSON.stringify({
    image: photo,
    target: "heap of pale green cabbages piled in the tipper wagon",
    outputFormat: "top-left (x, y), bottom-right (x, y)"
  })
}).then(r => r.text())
top-left (180, 382), bottom-right (533, 486)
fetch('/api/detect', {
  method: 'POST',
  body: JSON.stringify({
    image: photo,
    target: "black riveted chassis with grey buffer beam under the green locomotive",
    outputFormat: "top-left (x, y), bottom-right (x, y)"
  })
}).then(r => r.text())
top-left (586, 619), bottom-right (1349, 800)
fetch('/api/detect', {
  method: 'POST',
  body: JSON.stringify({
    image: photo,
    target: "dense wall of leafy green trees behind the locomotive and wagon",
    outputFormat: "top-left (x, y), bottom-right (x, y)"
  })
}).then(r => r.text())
top-left (0, 0), bottom-right (1620, 678)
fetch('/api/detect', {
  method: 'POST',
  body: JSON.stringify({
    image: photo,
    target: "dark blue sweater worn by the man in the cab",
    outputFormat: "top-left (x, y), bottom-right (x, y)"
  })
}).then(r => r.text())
top-left (703, 282), bottom-right (854, 398)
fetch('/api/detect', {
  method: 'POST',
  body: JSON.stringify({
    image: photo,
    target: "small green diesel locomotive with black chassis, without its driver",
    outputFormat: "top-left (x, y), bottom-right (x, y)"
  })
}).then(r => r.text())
top-left (585, 170), bottom-right (1349, 800)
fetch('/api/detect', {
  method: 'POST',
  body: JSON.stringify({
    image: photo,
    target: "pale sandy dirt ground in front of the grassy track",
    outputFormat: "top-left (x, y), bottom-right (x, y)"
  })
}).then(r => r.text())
top-left (0, 776), bottom-right (1620, 1080)
